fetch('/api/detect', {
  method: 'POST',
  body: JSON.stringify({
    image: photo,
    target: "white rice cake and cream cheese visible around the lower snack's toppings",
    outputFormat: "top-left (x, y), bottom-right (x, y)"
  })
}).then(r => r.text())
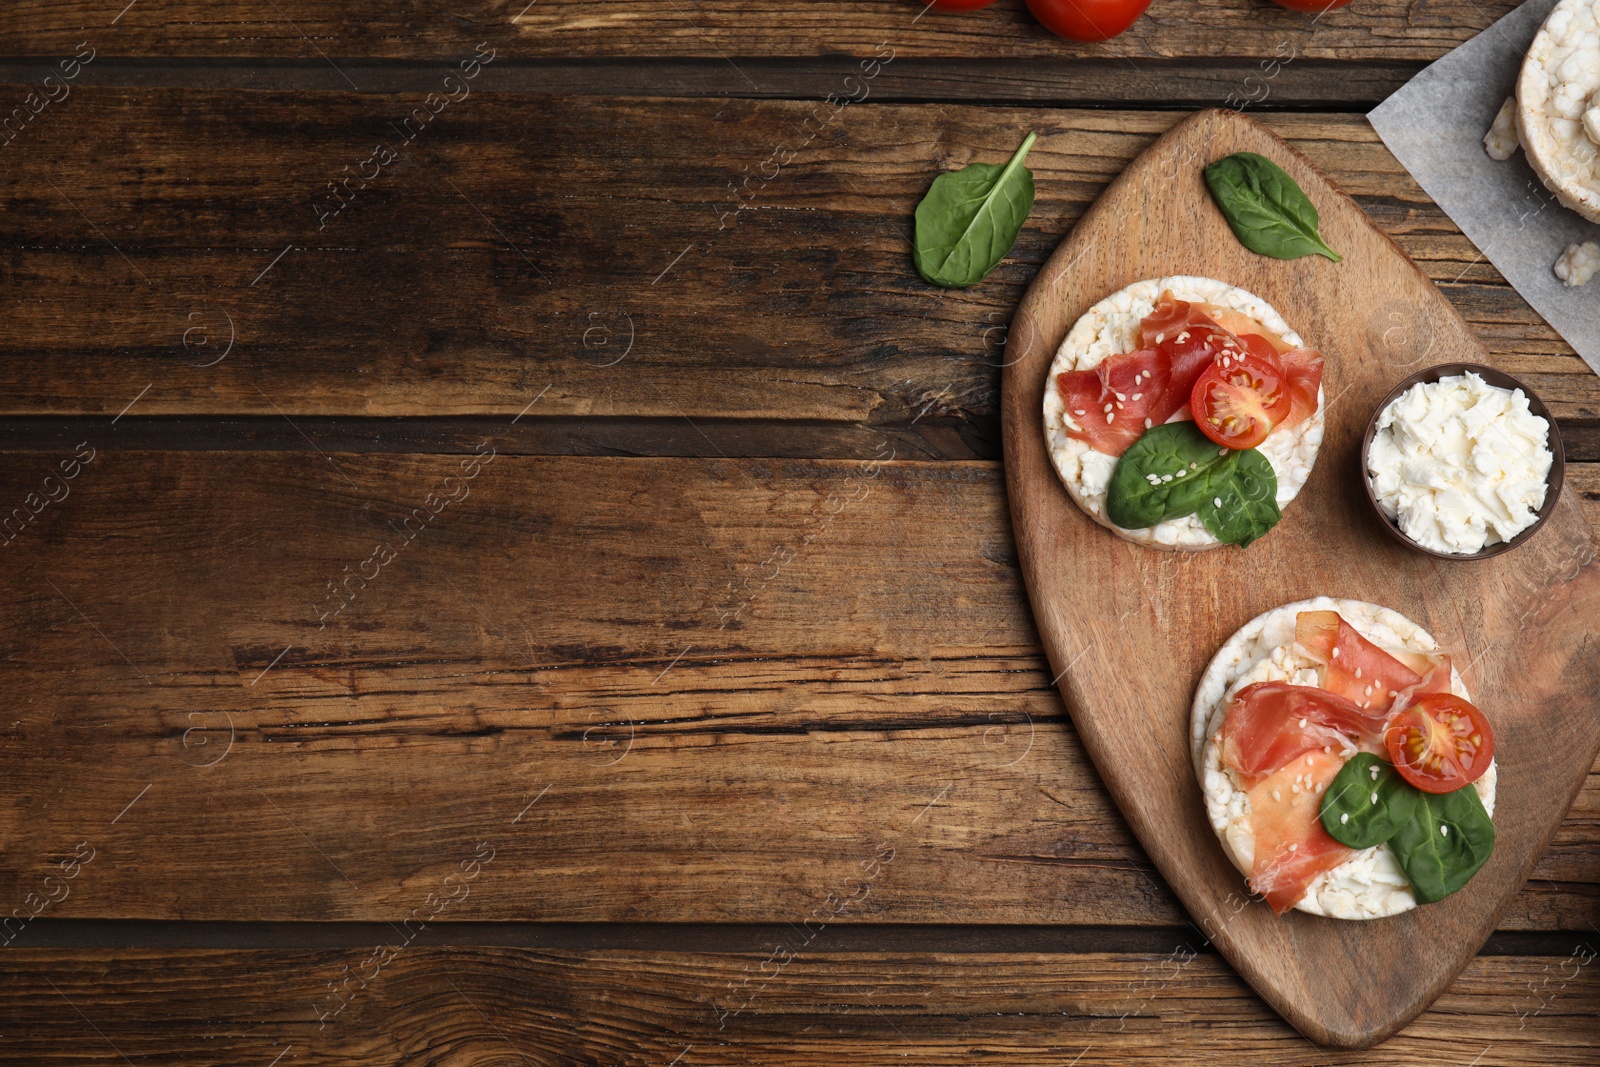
top-left (1189, 597), bottom-right (1499, 918)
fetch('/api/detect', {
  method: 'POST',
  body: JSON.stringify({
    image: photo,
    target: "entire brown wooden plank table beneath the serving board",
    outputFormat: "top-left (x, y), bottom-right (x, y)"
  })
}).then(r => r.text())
top-left (0, 0), bottom-right (1600, 1067)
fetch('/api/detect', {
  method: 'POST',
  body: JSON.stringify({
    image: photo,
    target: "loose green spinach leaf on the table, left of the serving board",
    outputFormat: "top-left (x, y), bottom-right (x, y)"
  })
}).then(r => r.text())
top-left (912, 133), bottom-right (1038, 290)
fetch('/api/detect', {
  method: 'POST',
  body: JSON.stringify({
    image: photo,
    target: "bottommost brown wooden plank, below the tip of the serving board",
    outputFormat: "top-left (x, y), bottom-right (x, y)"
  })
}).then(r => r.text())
top-left (0, 947), bottom-right (1600, 1067)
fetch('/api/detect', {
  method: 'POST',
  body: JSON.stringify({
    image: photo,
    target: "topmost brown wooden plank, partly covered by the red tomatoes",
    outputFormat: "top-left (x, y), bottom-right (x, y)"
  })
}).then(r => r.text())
top-left (0, 0), bottom-right (1514, 62)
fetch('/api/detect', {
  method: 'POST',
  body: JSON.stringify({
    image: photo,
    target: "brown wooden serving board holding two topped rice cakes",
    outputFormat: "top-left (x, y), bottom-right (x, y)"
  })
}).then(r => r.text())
top-left (1003, 110), bottom-right (1600, 1048)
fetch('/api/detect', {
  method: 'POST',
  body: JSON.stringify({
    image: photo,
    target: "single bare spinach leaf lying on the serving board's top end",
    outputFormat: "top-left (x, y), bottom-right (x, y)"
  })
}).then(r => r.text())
top-left (1205, 152), bottom-right (1339, 262)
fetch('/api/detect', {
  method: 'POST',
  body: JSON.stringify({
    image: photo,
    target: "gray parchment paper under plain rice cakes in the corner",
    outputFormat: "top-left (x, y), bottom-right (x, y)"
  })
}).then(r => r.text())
top-left (1366, 0), bottom-right (1600, 371)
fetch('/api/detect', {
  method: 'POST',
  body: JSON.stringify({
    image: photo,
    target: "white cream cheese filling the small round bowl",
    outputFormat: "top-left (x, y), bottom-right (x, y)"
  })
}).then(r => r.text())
top-left (1366, 371), bottom-right (1554, 553)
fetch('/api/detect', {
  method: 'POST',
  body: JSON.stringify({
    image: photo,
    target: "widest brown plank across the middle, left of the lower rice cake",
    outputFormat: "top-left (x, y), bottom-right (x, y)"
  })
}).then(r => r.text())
top-left (0, 451), bottom-right (1600, 927)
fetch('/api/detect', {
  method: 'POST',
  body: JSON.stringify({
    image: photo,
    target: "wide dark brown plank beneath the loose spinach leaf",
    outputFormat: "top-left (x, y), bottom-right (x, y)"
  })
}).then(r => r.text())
top-left (0, 88), bottom-right (1600, 425)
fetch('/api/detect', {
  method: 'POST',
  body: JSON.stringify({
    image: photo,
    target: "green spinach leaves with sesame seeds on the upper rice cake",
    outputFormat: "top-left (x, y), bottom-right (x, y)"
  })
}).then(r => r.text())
top-left (1106, 421), bottom-right (1283, 545)
